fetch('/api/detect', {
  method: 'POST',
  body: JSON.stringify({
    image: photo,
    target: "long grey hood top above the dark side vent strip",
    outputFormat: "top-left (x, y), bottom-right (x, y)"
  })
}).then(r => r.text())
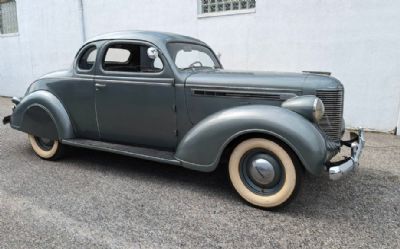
top-left (186, 69), bottom-right (341, 94)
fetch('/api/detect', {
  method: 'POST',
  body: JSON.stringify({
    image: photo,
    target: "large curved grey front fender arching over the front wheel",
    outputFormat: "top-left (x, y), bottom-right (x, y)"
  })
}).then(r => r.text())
top-left (175, 105), bottom-right (327, 175)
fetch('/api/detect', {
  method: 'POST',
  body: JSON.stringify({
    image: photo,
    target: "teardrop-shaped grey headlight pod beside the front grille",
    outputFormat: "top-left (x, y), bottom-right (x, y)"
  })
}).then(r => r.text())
top-left (282, 95), bottom-right (325, 123)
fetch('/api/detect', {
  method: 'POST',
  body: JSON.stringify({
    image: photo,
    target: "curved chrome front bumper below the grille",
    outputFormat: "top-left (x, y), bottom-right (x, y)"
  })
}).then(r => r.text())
top-left (329, 128), bottom-right (365, 180)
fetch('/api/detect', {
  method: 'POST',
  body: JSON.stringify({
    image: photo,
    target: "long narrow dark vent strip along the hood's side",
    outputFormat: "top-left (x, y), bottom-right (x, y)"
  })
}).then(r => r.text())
top-left (192, 89), bottom-right (296, 101)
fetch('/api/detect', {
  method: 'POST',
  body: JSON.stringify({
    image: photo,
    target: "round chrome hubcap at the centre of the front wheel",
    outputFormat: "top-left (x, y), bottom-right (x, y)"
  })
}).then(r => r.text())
top-left (249, 158), bottom-right (275, 185)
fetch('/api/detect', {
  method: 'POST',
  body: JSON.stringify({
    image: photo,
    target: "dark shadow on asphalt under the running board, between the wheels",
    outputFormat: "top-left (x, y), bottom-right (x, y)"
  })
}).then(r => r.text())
top-left (54, 144), bottom-right (239, 199)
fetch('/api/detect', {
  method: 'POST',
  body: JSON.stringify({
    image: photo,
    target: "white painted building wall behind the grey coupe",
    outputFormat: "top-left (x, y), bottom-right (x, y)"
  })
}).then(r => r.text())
top-left (0, 0), bottom-right (400, 131)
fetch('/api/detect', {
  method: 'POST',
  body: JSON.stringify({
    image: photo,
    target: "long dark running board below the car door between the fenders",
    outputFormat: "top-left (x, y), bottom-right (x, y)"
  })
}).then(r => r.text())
top-left (62, 139), bottom-right (181, 165)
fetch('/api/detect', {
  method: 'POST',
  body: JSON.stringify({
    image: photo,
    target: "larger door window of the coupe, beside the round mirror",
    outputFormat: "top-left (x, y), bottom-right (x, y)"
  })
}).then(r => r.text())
top-left (102, 43), bottom-right (164, 73)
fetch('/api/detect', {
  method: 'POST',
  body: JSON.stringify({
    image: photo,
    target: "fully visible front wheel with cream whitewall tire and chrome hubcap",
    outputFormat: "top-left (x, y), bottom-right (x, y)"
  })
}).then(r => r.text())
top-left (229, 138), bottom-right (302, 208)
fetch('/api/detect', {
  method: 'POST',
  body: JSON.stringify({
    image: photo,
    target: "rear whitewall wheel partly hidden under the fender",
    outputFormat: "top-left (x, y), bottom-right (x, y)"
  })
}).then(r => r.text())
top-left (28, 135), bottom-right (64, 160)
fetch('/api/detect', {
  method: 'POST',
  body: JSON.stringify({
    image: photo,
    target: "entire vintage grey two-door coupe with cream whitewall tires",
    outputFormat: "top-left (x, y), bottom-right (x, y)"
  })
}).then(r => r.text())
top-left (3, 31), bottom-right (364, 208)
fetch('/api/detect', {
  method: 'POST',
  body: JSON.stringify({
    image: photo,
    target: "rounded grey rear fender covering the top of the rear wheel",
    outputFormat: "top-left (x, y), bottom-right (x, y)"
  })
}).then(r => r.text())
top-left (10, 90), bottom-right (74, 139)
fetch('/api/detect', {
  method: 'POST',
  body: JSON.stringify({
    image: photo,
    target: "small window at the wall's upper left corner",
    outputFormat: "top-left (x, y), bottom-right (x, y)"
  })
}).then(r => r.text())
top-left (0, 0), bottom-right (18, 34)
